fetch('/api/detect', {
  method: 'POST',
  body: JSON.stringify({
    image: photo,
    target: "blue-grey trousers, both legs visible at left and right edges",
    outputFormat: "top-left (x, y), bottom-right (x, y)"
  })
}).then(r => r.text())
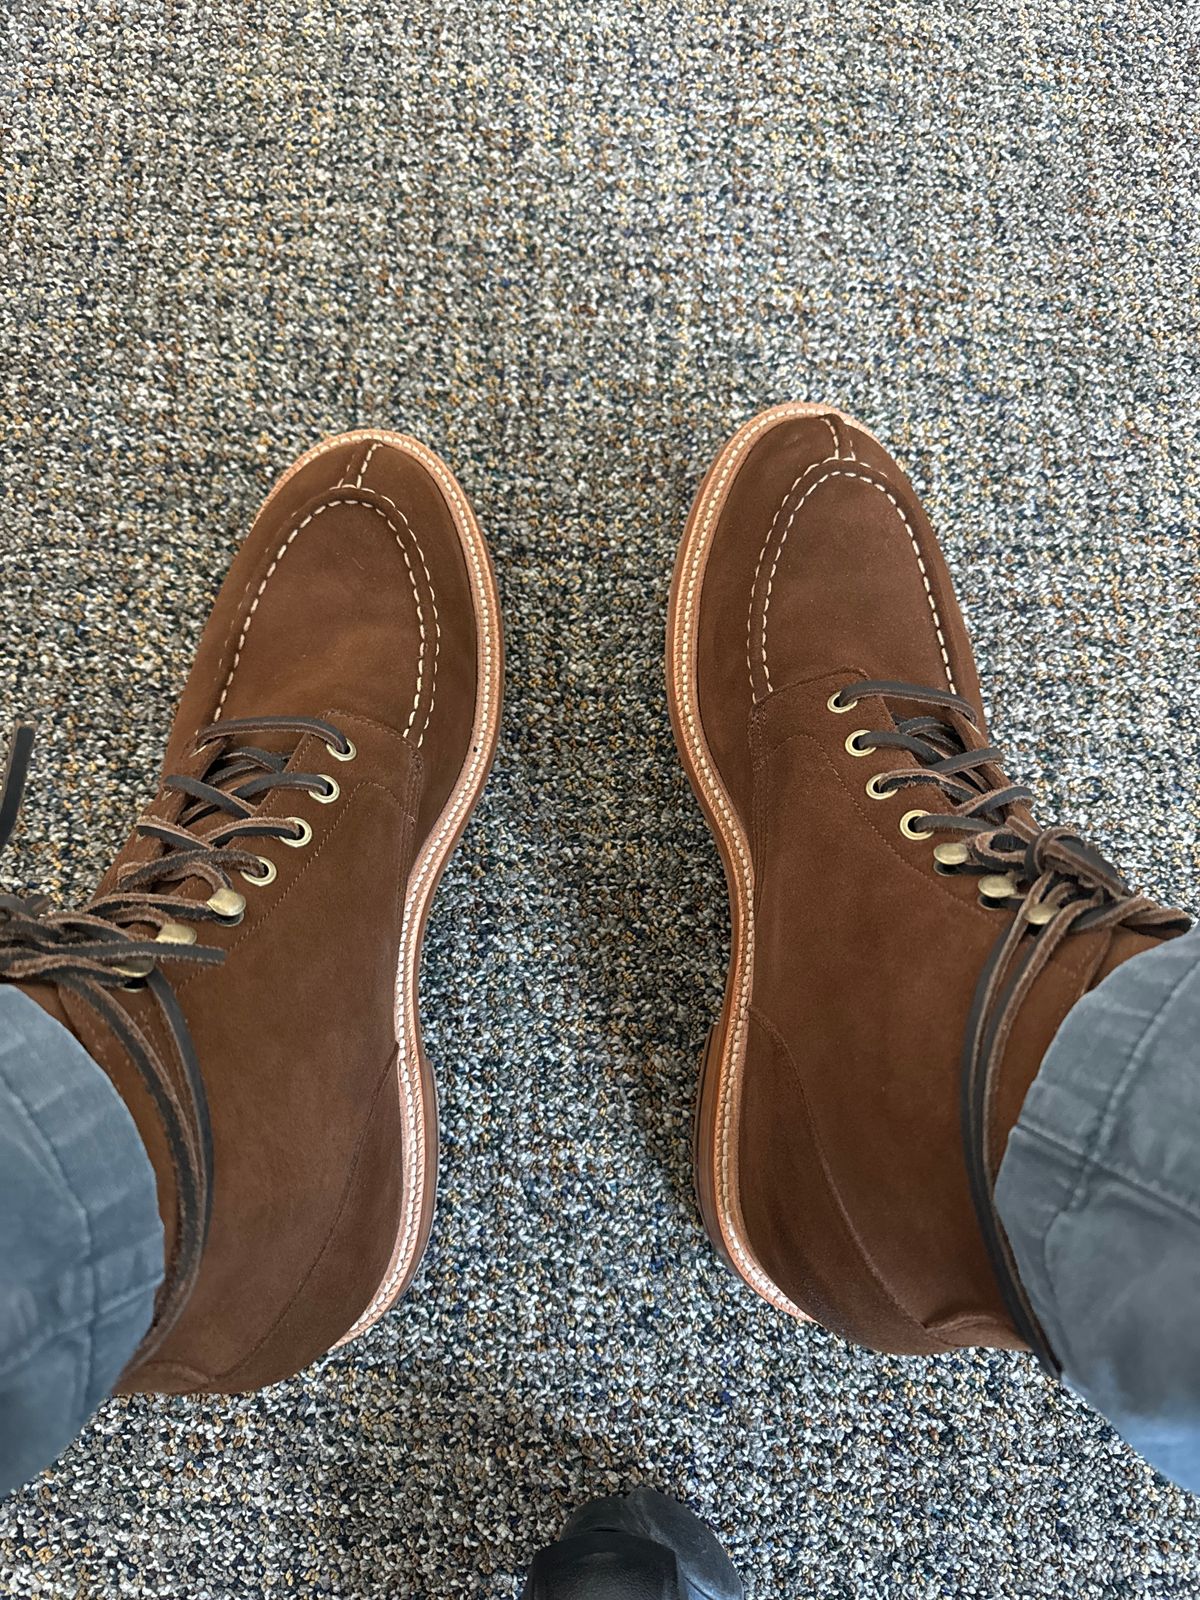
top-left (0, 931), bottom-right (1200, 1493)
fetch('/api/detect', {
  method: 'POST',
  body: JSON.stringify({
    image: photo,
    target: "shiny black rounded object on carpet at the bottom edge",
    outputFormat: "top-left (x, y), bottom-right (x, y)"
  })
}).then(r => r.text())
top-left (523, 1488), bottom-right (742, 1600)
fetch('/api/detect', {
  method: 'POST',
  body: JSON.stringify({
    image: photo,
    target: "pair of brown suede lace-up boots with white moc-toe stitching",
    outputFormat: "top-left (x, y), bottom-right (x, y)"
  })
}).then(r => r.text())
top-left (0, 405), bottom-right (1186, 1392)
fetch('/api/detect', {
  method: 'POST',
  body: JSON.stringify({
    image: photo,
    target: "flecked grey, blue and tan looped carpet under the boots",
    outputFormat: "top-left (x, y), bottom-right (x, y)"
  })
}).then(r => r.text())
top-left (0, 0), bottom-right (1200, 1600)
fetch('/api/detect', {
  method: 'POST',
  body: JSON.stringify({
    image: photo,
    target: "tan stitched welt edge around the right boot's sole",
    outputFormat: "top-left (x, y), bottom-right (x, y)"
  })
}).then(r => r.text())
top-left (666, 402), bottom-right (867, 1322)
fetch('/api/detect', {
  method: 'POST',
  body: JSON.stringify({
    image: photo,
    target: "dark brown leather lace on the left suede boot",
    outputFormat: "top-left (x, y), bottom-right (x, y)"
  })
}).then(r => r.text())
top-left (0, 717), bottom-right (352, 1370)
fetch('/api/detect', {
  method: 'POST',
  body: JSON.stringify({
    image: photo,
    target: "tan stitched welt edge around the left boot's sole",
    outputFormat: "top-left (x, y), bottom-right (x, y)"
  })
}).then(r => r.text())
top-left (259, 427), bottom-right (504, 1347)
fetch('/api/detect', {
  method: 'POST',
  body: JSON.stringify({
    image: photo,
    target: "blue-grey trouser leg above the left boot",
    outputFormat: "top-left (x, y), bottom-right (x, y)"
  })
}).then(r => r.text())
top-left (0, 984), bottom-right (163, 1494)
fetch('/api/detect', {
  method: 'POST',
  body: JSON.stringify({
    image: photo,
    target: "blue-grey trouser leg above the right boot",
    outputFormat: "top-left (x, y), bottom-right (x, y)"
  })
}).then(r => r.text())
top-left (997, 928), bottom-right (1200, 1491)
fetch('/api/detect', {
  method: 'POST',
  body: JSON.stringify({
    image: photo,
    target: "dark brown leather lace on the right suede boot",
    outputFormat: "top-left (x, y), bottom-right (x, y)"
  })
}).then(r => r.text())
top-left (837, 680), bottom-right (1190, 1376)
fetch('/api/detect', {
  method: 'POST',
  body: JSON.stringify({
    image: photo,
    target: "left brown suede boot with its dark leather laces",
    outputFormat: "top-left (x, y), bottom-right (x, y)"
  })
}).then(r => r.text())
top-left (0, 430), bottom-right (502, 1392)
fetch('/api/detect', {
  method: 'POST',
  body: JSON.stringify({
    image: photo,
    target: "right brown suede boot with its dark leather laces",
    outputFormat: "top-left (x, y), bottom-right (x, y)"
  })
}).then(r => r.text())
top-left (667, 405), bottom-right (1187, 1366)
